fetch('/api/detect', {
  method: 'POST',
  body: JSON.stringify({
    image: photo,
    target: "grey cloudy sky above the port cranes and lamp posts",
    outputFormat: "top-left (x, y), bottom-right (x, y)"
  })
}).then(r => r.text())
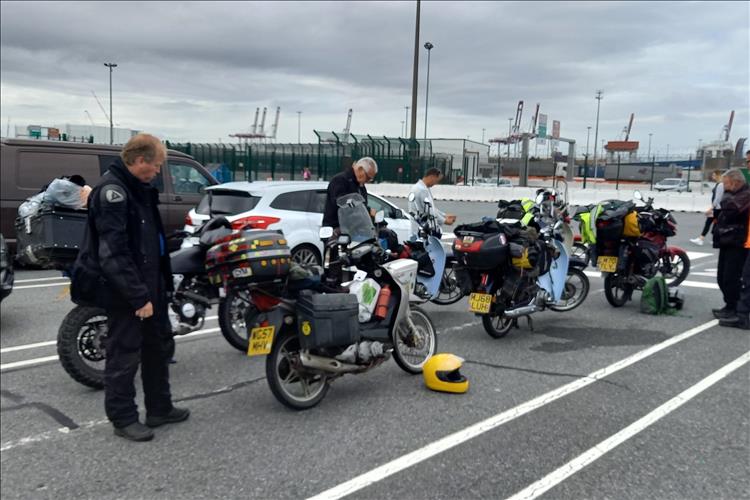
top-left (0, 1), bottom-right (750, 154)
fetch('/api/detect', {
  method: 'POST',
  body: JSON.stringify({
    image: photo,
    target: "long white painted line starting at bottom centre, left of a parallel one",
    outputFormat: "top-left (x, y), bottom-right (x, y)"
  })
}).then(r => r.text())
top-left (308, 320), bottom-right (719, 500)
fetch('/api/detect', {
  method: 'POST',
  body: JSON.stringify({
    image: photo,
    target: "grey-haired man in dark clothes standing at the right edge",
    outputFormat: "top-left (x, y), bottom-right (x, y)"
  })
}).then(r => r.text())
top-left (713, 168), bottom-right (750, 329)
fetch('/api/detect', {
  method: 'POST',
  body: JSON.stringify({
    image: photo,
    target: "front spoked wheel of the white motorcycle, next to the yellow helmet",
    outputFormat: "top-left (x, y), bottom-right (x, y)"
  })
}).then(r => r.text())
top-left (393, 306), bottom-right (437, 375)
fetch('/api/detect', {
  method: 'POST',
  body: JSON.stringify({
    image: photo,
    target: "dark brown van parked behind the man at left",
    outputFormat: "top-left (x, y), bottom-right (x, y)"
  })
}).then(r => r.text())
top-left (0, 139), bottom-right (218, 253)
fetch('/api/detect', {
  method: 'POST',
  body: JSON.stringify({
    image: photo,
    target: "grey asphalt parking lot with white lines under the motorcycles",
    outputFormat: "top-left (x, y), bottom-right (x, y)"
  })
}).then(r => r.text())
top-left (0, 204), bottom-right (750, 499)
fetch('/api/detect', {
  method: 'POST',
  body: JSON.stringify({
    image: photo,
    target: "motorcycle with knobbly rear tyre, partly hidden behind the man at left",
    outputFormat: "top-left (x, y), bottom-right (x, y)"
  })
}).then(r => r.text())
top-left (57, 217), bottom-right (241, 389)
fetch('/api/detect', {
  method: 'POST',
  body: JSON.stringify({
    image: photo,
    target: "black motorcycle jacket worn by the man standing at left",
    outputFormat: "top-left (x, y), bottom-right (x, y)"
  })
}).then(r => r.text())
top-left (71, 158), bottom-right (172, 310)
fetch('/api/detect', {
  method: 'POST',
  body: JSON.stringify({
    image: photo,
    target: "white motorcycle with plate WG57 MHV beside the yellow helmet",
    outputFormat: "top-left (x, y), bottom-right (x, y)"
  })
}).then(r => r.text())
top-left (253, 195), bottom-right (437, 410)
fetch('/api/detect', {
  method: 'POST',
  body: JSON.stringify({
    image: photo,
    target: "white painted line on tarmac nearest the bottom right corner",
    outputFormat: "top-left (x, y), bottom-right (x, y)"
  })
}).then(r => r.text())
top-left (508, 351), bottom-right (750, 500)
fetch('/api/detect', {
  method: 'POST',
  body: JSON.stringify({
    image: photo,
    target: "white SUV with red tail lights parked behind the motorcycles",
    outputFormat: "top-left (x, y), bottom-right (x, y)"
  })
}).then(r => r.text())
top-left (185, 181), bottom-right (418, 264)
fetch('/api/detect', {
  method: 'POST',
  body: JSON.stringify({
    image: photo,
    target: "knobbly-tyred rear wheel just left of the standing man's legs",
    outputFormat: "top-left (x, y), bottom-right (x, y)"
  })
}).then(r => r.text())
top-left (57, 306), bottom-right (108, 389)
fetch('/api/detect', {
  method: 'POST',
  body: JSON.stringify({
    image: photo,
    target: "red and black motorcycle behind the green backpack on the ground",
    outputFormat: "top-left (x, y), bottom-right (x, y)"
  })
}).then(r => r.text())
top-left (597, 191), bottom-right (690, 307)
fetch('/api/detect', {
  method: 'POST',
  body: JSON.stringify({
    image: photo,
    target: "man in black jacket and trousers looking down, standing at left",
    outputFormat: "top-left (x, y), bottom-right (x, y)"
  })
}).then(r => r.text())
top-left (71, 134), bottom-right (190, 441)
